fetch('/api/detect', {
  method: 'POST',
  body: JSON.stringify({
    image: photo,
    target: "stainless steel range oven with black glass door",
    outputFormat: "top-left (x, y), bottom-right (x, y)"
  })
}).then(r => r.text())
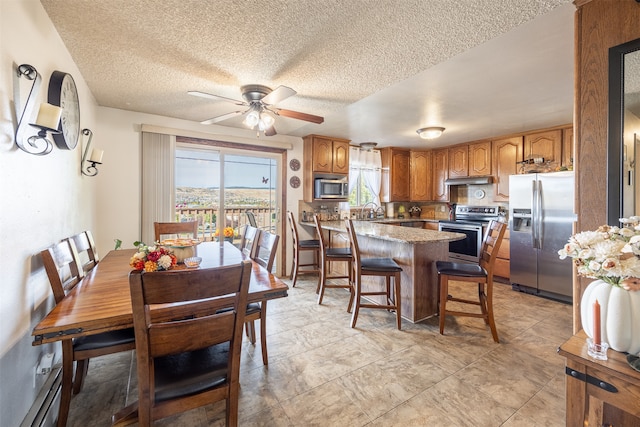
top-left (438, 205), bottom-right (504, 263)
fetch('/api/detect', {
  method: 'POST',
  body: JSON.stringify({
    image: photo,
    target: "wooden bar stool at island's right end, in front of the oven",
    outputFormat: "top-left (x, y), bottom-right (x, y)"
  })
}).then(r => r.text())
top-left (436, 220), bottom-right (507, 343)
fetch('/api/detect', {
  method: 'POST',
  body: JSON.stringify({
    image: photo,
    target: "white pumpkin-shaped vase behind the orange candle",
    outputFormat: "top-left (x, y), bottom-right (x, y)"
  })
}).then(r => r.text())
top-left (580, 280), bottom-right (640, 354)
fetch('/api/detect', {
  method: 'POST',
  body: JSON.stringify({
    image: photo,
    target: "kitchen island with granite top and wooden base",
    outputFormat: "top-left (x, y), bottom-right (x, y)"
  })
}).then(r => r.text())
top-left (301, 221), bottom-right (465, 323)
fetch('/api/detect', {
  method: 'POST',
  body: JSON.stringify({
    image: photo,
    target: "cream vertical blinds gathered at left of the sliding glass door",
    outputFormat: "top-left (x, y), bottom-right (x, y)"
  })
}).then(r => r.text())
top-left (140, 132), bottom-right (176, 244)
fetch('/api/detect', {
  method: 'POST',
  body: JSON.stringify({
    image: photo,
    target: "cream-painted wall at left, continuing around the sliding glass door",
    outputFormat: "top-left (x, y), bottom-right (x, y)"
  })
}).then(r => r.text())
top-left (0, 0), bottom-right (302, 426)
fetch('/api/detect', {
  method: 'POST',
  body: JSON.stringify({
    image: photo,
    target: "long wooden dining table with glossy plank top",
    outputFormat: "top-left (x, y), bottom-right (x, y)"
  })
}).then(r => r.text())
top-left (32, 242), bottom-right (289, 345)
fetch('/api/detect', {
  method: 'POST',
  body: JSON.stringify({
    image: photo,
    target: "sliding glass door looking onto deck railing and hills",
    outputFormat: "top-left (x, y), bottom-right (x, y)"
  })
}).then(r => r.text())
top-left (175, 144), bottom-right (281, 270)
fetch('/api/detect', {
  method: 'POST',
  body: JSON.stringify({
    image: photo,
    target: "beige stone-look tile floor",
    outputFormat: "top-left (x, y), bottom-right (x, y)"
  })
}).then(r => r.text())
top-left (68, 278), bottom-right (571, 427)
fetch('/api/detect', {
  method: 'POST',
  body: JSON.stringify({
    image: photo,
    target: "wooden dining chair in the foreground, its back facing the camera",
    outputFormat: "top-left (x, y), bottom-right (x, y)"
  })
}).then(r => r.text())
top-left (112, 260), bottom-right (252, 426)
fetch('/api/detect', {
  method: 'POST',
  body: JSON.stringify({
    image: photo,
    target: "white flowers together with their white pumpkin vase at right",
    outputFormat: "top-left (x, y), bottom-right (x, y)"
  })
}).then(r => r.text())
top-left (558, 216), bottom-right (640, 357)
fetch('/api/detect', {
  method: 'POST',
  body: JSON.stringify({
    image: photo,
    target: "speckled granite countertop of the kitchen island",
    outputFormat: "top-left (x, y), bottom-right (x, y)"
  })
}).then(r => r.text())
top-left (302, 219), bottom-right (465, 244)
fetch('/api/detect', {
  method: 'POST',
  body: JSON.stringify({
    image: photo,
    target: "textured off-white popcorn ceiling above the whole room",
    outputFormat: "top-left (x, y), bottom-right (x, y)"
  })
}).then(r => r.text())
top-left (41, 0), bottom-right (575, 147)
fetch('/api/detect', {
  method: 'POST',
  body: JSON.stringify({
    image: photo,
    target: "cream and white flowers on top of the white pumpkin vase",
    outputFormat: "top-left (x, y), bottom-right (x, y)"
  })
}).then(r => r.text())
top-left (558, 216), bottom-right (640, 290)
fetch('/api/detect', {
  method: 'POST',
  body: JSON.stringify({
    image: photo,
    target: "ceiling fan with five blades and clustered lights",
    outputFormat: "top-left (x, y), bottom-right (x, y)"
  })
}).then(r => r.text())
top-left (188, 85), bottom-right (324, 136)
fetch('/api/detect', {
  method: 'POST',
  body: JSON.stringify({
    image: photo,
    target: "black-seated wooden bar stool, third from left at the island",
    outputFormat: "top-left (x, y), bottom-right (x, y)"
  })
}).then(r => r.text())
top-left (345, 219), bottom-right (402, 330)
